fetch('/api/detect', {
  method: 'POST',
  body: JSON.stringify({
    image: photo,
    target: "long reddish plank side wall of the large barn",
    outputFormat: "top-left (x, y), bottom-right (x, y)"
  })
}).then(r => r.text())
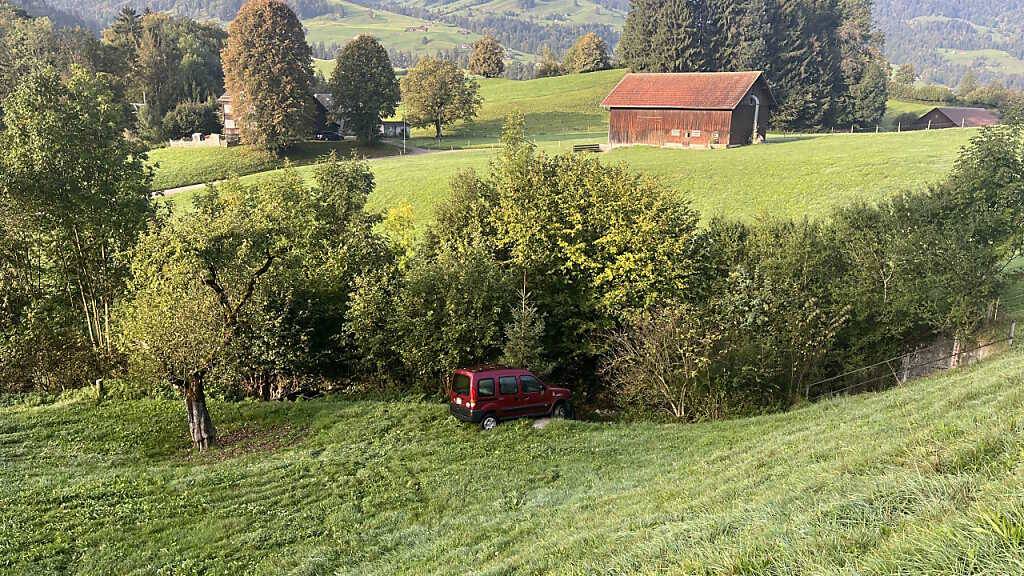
top-left (608, 109), bottom-right (732, 147)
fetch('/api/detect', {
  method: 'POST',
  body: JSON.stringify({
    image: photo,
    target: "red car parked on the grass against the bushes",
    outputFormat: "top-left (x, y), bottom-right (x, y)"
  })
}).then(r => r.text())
top-left (449, 367), bottom-right (572, 430)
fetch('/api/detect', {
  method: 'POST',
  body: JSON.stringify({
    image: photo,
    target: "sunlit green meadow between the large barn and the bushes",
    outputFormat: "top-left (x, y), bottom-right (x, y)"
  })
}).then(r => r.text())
top-left (169, 129), bottom-right (976, 227)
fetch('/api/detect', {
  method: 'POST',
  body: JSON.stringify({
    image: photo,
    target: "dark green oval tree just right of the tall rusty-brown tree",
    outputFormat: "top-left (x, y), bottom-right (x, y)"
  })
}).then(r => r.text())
top-left (330, 34), bottom-right (401, 143)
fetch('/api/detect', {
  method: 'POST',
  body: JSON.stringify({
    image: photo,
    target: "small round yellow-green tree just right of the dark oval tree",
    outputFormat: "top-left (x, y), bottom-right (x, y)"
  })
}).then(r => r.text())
top-left (401, 56), bottom-right (483, 140)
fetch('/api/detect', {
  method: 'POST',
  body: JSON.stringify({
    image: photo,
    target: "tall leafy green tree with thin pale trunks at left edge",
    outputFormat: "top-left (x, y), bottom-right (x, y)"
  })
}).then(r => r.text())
top-left (0, 68), bottom-right (155, 378)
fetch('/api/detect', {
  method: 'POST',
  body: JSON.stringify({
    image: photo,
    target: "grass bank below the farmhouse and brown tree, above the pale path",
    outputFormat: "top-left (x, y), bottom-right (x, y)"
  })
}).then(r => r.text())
top-left (150, 141), bottom-right (398, 190)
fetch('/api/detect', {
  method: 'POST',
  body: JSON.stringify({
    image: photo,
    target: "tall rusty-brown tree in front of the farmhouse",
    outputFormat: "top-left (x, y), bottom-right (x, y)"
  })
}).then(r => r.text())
top-left (222, 0), bottom-right (314, 152)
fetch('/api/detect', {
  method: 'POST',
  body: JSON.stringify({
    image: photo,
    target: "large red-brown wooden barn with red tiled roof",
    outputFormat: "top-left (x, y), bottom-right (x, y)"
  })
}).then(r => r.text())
top-left (601, 72), bottom-right (775, 148)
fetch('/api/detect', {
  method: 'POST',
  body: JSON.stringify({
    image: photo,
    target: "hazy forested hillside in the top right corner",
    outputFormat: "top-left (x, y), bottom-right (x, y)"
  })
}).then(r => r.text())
top-left (874, 0), bottom-right (1024, 88)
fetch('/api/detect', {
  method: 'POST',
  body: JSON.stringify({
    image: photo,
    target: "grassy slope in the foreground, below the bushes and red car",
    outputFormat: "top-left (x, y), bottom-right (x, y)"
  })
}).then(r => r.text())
top-left (6, 354), bottom-right (1024, 576)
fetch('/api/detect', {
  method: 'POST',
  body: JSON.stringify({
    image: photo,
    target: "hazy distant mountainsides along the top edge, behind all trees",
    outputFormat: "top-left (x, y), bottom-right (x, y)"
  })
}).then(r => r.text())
top-left (13, 0), bottom-right (1024, 88)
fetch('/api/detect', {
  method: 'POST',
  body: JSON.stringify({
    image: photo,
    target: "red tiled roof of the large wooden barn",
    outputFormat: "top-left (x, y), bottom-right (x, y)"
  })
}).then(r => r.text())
top-left (601, 72), bottom-right (763, 110)
